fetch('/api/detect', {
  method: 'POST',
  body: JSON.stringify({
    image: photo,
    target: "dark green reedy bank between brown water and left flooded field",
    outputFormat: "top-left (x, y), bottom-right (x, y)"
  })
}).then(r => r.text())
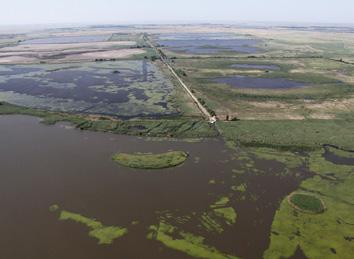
top-left (0, 102), bottom-right (218, 138)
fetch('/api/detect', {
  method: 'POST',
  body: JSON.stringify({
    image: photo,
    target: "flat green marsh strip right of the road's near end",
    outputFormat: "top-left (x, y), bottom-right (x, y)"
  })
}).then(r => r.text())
top-left (218, 120), bottom-right (354, 151)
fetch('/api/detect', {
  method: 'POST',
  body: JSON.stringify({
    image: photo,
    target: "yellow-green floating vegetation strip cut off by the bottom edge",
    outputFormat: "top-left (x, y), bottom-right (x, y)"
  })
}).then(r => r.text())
top-left (148, 222), bottom-right (237, 259)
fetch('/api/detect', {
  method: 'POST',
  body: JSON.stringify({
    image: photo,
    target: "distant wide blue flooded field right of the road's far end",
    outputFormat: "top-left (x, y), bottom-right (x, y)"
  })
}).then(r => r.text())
top-left (157, 33), bottom-right (259, 54)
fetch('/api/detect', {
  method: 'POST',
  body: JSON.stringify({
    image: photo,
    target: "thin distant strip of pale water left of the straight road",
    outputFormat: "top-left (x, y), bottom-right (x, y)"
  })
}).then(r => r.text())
top-left (20, 35), bottom-right (111, 45)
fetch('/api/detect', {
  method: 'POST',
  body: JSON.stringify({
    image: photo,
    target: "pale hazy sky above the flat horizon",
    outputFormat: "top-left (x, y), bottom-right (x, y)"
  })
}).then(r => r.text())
top-left (0, 0), bottom-right (354, 25)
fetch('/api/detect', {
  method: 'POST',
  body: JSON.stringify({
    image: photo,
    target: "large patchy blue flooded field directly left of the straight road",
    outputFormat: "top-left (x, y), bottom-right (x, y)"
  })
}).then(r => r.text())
top-left (0, 61), bottom-right (176, 117)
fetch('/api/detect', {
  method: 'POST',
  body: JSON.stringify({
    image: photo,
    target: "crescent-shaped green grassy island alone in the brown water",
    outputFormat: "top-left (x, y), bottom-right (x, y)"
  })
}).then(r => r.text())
top-left (112, 151), bottom-right (188, 169)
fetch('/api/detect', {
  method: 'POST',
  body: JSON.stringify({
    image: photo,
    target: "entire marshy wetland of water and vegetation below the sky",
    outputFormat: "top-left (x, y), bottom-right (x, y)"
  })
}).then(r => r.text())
top-left (0, 24), bottom-right (354, 259)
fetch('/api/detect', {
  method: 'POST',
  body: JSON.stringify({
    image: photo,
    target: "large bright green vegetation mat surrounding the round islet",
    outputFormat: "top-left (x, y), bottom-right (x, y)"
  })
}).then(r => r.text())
top-left (264, 150), bottom-right (354, 259)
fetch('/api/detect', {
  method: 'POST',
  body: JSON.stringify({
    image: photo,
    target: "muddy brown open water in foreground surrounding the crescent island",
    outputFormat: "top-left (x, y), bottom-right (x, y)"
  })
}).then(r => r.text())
top-left (0, 116), bottom-right (306, 259)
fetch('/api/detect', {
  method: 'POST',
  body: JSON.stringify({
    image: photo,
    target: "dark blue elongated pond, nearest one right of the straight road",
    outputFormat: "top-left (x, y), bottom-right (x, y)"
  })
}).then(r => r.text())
top-left (213, 76), bottom-right (304, 89)
